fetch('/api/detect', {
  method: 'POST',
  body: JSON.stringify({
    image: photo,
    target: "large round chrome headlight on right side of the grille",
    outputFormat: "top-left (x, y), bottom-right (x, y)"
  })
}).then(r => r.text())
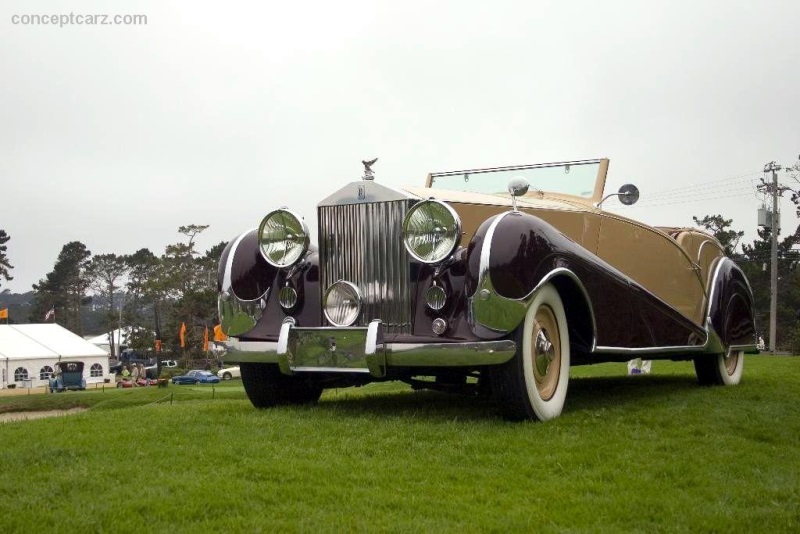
top-left (403, 200), bottom-right (461, 263)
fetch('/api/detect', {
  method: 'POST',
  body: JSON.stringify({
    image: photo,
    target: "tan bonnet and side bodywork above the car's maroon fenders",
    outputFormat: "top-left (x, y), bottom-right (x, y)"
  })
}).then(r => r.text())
top-left (404, 176), bottom-right (723, 325)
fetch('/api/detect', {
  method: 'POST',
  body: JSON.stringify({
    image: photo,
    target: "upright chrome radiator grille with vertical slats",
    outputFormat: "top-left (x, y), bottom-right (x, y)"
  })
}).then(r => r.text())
top-left (319, 200), bottom-right (411, 334)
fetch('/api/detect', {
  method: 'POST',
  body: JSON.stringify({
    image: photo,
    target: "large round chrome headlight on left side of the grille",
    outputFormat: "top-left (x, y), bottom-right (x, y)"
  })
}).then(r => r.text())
top-left (258, 208), bottom-right (310, 268)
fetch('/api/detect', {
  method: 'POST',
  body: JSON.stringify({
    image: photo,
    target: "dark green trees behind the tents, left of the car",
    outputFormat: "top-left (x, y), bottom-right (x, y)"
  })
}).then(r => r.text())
top-left (0, 224), bottom-right (226, 358)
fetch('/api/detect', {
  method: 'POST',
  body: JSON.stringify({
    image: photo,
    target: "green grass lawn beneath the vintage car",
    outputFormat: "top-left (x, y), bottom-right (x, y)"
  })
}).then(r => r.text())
top-left (0, 356), bottom-right (800, 532)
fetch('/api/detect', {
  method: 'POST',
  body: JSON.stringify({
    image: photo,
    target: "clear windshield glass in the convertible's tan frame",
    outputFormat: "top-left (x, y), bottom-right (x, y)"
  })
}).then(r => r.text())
top-left (429, 159), bottom-right (607, 202)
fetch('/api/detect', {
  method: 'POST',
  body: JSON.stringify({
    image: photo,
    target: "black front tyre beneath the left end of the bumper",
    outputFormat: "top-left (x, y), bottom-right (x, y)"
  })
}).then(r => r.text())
top-left (240, 363), bottom-right (322, 408)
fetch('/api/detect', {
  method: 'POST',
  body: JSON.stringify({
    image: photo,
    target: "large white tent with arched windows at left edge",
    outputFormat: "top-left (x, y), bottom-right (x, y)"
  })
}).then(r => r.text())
top-left (0, 323), bottom-right (108, 389)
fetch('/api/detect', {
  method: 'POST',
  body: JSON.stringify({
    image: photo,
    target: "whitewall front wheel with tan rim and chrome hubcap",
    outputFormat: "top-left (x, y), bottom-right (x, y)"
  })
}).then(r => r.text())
top-left (492, 284), bottom-right (570, 421)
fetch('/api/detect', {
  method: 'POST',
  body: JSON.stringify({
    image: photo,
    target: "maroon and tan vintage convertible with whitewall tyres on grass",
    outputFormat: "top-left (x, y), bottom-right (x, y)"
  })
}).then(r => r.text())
top-left (218, 159), bottom-right (756, 420)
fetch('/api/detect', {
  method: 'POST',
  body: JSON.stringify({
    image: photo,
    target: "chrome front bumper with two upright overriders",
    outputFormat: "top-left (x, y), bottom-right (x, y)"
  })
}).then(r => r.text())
top-left (225, 320), bottom-right (516, 378)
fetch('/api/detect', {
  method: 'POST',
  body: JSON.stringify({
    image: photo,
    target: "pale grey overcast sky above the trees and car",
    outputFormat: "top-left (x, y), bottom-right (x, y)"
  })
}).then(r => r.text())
top-left (0, 0), bottom-right (800, 292)
